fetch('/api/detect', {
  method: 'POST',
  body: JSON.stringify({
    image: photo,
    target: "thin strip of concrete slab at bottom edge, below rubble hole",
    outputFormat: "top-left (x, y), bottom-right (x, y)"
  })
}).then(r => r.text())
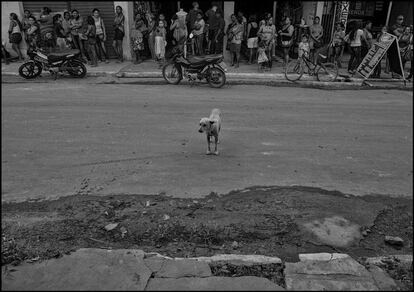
top-left (145, 276), bottom-right (285, 291)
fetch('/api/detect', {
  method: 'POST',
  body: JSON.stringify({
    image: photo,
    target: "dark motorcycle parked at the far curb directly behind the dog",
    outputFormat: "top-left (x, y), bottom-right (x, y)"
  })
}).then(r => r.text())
top-left (162, 35), bottom-right (226, 88)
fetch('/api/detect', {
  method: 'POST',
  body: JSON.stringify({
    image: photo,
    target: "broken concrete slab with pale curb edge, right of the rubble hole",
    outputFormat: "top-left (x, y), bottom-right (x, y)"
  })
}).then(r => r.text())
top-left (285, 255), bottom-right (378, 291)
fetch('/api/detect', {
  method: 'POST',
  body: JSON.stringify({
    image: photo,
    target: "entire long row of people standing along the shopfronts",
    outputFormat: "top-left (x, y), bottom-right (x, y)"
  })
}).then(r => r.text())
top-left (4, 2), bottom-right (413, 77)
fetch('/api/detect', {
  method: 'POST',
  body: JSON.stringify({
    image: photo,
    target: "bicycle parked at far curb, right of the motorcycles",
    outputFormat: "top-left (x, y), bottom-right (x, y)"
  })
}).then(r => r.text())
top-left (285, 54), bottom-right (338, 82)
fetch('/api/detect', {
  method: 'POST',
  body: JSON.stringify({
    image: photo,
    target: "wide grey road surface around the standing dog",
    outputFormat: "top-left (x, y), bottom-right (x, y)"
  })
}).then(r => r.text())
top-left (2, 80), bottom-right (413, 201)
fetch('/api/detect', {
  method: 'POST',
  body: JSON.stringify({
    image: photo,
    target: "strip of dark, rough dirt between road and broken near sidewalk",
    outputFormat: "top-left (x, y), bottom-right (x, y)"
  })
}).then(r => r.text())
top-left (1, 187), bottom-right (413, 265)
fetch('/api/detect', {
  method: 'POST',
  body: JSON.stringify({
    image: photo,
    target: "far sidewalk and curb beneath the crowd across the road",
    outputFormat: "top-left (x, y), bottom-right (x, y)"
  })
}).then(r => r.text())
top-left (2, 56), bottom-right (412, 90)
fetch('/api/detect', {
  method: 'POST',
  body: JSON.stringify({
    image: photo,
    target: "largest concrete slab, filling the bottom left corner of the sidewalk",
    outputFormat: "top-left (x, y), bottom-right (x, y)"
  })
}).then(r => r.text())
top-left (1, 249), bottom-right (151, 291)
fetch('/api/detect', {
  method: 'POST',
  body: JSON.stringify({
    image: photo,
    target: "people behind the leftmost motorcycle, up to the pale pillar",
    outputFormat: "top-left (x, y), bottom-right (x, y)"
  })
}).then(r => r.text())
top-left (9, 6), bottom-right (125, 66)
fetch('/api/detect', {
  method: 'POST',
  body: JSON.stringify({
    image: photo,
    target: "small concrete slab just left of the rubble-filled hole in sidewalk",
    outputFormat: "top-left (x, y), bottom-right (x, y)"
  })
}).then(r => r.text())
top-left (153, 259), bottom-right (212, 278)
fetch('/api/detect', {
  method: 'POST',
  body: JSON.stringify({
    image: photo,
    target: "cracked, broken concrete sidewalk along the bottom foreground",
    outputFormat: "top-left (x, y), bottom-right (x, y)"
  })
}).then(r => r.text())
top-left (2, 248), bottom-right (412, 291)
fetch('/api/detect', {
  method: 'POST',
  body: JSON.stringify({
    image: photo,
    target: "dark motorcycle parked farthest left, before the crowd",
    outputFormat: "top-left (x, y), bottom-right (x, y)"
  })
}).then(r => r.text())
top-left (19, 49), bottom-right (86, 80)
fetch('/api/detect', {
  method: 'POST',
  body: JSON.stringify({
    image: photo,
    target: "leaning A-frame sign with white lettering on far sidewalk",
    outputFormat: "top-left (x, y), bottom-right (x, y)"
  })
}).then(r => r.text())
top-left (357, 33), bottom-right (403, 79)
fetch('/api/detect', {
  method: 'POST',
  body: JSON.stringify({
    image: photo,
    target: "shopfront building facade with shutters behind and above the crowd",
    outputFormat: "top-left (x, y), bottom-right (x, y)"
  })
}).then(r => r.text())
top-left (1, 0), bottom-right (413, 60)
